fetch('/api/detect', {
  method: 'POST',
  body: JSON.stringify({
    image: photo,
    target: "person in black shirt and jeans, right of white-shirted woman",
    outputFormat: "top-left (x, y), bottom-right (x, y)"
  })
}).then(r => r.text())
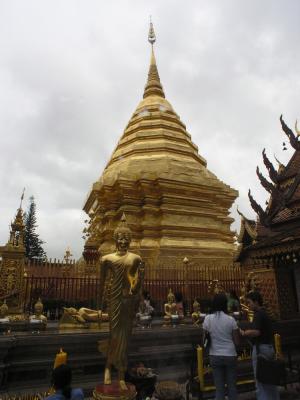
top-left (240, 291), bottom-right (279, 400)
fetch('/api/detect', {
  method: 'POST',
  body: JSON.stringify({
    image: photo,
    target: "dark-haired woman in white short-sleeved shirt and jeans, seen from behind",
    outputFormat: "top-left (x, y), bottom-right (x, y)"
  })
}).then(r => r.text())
top-left (203, 293), bottom-right (239, 400)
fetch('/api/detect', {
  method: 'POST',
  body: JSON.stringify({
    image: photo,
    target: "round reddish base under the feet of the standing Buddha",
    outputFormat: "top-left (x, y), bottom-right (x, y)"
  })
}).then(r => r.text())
top-left (93, 382), bottom-right (136, 400)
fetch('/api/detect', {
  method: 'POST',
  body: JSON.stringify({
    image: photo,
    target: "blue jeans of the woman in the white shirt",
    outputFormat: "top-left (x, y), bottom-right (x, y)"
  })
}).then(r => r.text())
top-left (209, 356), bottom-right (237, 400)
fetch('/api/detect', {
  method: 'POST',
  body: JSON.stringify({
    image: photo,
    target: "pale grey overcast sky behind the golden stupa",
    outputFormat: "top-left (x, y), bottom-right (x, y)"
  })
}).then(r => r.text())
top-left (0, 0), bottom-right (300, 258)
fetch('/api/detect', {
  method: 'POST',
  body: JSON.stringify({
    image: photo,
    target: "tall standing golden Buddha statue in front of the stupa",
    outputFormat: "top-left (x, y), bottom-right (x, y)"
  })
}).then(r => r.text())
top-left (99, 214), bottom-right (144, 390)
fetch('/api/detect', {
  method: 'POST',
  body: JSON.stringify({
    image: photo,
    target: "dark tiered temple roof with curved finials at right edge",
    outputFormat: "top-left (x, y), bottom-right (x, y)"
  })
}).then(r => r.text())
top-left (238, 116), bottom-right (300, 260)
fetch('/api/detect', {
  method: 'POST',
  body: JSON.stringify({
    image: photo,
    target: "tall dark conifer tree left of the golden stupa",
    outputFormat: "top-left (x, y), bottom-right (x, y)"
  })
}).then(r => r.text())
top-left (24, 196), bottom-right (47, 260)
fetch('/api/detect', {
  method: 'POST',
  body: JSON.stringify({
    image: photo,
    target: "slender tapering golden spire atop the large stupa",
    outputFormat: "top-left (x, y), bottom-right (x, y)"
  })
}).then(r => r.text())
top-left (143, 18), bottom-right (165, 99)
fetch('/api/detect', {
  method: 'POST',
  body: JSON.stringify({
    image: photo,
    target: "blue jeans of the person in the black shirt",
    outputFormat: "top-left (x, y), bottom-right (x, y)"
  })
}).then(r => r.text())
top-left (252, 344), bottom-right (279, 400)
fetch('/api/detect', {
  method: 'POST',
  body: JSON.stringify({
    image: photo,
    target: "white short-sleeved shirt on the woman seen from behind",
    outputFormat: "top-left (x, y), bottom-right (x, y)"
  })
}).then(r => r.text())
top-left (203, 311), bottom-right (238, 357)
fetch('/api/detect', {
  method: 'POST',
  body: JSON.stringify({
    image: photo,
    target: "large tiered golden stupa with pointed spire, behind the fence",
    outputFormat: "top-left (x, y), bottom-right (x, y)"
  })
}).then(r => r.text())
top-left (84, 24), bottom-right (238, 268)
